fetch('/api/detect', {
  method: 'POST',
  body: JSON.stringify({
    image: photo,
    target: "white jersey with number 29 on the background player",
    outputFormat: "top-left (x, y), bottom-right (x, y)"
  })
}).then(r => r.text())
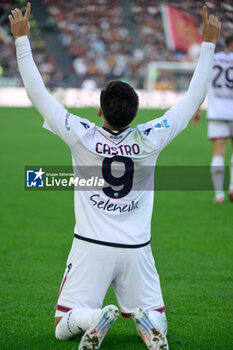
top-left (207, 52), bottom-right (233, 120)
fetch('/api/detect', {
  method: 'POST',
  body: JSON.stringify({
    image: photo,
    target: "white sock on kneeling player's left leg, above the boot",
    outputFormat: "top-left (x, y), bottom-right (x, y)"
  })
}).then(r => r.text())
top-left (55, 308), bottom-right (101, 340)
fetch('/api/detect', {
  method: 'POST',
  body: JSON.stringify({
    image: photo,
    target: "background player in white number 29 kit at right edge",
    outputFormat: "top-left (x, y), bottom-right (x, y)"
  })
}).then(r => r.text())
top-left (194, 35), bottom-right (233, 203)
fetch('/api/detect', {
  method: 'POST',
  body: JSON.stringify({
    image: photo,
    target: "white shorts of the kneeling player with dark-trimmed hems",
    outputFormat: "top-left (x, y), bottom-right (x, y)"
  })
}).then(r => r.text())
top-left (55, 238), bottom-right (164, 317)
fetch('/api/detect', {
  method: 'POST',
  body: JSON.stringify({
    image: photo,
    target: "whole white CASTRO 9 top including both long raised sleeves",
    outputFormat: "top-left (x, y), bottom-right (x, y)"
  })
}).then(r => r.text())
top-left (15, 36), bottom-right (215, 247)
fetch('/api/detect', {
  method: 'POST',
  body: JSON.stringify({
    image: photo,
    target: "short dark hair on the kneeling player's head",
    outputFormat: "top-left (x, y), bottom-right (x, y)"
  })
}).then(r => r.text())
top-left (100, 80), bottom-right (139, 128)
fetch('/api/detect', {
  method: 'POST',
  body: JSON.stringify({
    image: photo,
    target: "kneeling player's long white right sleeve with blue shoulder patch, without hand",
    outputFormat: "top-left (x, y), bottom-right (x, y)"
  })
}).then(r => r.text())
top-left (138, 42), bottom-right (215, 151)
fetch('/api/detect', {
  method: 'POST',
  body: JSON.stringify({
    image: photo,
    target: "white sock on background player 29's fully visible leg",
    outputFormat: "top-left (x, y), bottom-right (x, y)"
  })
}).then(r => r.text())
top-left (211, 156), bottom-right (225, 200)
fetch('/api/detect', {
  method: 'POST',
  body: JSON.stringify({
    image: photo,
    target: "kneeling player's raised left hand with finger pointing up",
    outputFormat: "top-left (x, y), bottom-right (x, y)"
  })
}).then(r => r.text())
top-left (9, 2), bottom-right (31, 39)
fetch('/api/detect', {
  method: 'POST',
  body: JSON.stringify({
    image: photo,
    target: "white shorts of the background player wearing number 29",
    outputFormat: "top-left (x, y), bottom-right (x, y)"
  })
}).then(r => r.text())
top-left (208, 120), bottom-right (233, 139)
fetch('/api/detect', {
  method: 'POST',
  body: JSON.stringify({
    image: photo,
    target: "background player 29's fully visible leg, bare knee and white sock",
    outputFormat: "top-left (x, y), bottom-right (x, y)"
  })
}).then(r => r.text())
top-left (211, 138), bottom-right (226, 203)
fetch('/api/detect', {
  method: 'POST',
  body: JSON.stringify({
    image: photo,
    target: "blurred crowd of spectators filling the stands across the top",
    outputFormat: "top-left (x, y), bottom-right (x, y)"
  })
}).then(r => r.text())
top-left (0, 0), bottom-right (233, 89)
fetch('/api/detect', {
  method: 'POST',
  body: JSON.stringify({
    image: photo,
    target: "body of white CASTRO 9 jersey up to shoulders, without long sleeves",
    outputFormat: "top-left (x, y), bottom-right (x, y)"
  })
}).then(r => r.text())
top-left (43, 107), bottom-right (187, 247)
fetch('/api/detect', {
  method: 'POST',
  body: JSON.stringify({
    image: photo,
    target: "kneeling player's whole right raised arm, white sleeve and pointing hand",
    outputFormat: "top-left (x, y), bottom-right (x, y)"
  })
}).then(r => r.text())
top-left (141, 6), bottom-right (221, 151)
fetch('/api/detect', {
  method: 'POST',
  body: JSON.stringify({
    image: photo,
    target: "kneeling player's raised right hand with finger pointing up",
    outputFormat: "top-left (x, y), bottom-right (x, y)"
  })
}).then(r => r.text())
top-left (202, 6), bottom-right (221, 44)
